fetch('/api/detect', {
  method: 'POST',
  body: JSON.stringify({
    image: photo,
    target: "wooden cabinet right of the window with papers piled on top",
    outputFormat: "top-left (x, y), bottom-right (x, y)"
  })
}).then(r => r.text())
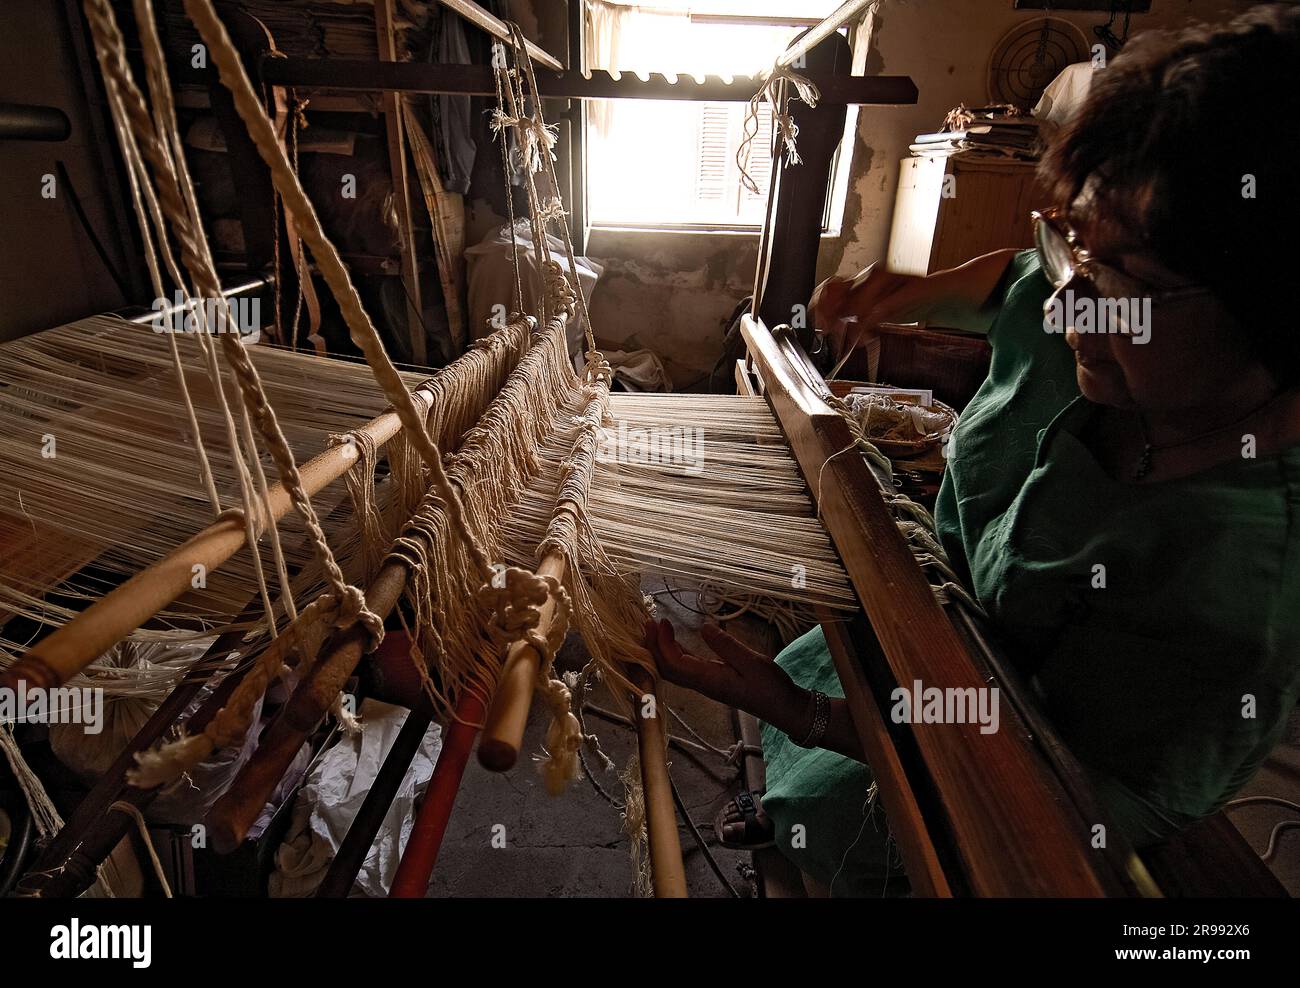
top-left (888, 155), bottom-right (1048, 274)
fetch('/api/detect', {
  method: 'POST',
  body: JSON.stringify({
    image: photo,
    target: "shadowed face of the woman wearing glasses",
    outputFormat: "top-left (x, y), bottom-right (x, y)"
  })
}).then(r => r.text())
top-left (1049, 218), bottom-right (1257, 412)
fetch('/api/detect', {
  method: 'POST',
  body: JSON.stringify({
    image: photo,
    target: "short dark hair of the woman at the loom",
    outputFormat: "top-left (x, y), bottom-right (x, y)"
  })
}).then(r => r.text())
top-left (1039, 5), bottom-right (1300, 386)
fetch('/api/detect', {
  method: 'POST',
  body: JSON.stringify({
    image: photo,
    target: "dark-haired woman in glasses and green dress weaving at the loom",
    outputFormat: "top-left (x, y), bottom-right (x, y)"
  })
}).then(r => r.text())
top-left (647, 7), bottom-right (1300, 893)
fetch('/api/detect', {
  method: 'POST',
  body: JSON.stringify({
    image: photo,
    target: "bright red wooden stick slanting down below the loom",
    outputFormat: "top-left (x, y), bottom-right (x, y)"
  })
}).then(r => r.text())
top-left (389, 693), bottom-right (485, 898)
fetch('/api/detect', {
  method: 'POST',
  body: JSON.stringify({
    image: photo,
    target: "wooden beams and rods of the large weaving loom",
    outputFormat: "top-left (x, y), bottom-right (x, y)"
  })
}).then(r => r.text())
top-left (0, 0), bottom-right (1279, 896)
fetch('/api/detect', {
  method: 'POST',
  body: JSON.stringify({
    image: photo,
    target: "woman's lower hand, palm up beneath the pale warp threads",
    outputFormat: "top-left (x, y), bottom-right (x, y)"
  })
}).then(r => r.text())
top-left (645, 620), bottom-right (807, 724)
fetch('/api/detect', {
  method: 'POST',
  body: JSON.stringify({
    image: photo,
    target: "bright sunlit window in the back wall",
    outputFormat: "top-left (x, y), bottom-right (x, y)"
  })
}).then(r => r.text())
top-left (586, 0), bottom-right (857, 230)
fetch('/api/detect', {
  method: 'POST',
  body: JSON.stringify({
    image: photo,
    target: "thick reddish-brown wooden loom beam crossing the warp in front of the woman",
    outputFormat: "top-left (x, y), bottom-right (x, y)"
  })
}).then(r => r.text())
top-left (741, 316), bottom-right (1125, 897)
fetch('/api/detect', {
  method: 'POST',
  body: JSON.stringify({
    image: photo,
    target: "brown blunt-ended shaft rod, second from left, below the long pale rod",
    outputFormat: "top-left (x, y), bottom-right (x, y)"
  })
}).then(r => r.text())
top-left (207, 559), bottom-right (411, 854)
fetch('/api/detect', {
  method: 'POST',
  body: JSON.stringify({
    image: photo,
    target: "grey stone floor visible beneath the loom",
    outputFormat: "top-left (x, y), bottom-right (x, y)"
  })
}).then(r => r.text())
top-left (429, 594), bottom-right (754, 898)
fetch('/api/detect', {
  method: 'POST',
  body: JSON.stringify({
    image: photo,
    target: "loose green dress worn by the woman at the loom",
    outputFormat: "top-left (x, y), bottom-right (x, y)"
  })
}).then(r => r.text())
top-left (763, 251), bottom-right (1300, 894)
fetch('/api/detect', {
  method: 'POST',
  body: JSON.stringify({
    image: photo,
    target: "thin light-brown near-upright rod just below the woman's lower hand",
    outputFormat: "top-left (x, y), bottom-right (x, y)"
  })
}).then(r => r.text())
top-left (628, 666), bottom-right (686, 898)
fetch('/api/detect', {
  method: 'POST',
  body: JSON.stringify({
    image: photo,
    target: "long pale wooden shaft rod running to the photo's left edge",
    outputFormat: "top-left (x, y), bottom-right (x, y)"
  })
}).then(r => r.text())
top-left (0, 391), bottom-right (429, 689)
